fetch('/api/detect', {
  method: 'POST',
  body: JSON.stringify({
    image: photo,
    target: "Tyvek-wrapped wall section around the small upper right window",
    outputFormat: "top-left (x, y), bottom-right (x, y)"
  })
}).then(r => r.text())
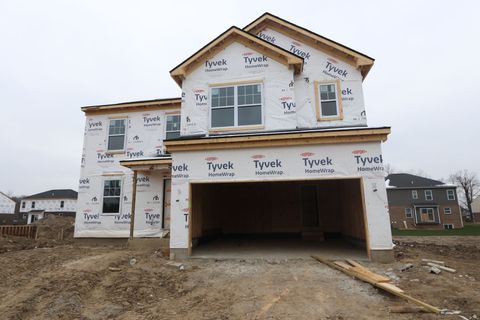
top-left (253, 28), bottom-right (367, 128)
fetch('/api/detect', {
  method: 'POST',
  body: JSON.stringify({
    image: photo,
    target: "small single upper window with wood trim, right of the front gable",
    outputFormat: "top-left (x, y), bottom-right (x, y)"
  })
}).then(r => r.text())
top-left (315, 81), bottom-right (343, 121)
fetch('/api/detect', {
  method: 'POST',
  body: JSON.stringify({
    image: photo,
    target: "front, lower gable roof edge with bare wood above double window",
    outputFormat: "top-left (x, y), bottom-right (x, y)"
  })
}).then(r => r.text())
top-left (170, 26), bottom-right (303, 86)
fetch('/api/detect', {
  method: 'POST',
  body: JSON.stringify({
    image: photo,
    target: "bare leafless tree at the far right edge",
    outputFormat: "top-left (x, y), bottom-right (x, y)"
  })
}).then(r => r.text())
top-left (450, 169), bottom-right (480, 222)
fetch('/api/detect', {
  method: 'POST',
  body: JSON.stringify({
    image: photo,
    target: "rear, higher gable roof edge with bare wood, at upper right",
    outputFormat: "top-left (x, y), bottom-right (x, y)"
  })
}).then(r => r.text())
top-left (243, 12), bottom-right (375, 78)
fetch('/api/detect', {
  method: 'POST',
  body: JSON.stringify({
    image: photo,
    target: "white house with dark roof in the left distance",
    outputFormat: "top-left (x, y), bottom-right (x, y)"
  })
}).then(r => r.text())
top-left (20, 189), bottom-right (78, 224)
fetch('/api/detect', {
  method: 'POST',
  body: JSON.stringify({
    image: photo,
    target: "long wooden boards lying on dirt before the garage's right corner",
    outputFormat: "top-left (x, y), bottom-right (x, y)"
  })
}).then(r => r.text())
top-left (312, 256), bottom-right (442, 314)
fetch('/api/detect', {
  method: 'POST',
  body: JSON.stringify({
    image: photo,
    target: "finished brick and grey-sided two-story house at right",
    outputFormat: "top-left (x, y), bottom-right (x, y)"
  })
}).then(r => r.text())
top-left (385, 173), bottom-right (463, 229)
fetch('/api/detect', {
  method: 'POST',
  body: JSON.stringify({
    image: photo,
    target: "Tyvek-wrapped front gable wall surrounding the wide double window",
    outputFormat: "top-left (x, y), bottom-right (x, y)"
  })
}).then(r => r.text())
top-left (181, 43), bottom-right (297, 135)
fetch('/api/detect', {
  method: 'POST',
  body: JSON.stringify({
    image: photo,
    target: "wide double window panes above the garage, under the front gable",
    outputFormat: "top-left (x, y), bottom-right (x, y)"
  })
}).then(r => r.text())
top-left (210, 83), bottom-right (263, 128)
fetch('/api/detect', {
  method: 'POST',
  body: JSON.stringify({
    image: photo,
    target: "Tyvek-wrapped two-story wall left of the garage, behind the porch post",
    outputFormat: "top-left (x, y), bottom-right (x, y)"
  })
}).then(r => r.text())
top-left (75, 109), bottom-right (179, 237)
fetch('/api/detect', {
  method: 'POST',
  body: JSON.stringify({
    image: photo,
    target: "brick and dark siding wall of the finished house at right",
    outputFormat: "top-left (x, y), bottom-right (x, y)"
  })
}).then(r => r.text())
top-left (387, 187), bottom-right (463, 229)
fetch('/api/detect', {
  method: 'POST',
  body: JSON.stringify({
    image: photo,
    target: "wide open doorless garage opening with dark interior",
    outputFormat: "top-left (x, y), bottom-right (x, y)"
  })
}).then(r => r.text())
top-left (190, 179), bottom-right (367, 259)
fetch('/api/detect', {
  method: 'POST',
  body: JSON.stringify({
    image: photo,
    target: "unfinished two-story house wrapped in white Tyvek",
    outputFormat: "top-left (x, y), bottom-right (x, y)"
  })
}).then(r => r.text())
top-left (75, 13), bottom-right (393, 260)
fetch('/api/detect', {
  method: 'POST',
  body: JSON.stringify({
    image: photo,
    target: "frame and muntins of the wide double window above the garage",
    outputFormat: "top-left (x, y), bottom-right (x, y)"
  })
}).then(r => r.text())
top-left (208, 80), bottom-right (265, 132)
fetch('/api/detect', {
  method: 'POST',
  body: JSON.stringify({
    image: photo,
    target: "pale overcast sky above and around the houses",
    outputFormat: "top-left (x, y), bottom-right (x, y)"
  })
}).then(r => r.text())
top-left (0, 0), bottom-right (480, 195)
